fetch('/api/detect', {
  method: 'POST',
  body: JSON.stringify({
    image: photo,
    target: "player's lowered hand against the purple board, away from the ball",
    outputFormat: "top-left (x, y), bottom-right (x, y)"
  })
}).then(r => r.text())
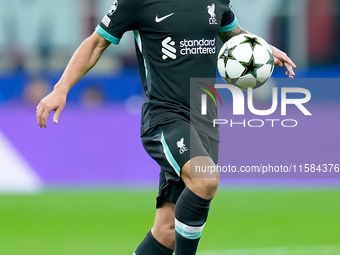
top-left (36, 89), bottom-right (67, 128)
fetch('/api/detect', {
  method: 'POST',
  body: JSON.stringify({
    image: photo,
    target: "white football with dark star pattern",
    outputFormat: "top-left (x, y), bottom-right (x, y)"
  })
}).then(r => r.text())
top-left (217, 34), bottom-right (274, 90)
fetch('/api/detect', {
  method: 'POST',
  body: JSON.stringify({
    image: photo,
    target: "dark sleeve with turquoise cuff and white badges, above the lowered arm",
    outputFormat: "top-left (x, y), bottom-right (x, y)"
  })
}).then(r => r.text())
top-left (96, 0), bottom-right (138, 44)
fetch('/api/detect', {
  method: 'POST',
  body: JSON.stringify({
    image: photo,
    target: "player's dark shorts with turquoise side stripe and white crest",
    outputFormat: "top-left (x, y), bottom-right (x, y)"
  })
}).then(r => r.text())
top-left (142, 119), bottom-right (209, 208)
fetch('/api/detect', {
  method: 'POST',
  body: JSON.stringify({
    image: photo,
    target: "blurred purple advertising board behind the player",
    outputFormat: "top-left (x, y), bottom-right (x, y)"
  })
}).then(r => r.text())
top-left (0, 90), bottom-right (340, 187)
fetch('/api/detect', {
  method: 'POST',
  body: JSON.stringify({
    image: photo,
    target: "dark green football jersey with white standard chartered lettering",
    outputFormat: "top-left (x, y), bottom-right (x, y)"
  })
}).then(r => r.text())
top-left (96, 0), bottom-right (237, 139)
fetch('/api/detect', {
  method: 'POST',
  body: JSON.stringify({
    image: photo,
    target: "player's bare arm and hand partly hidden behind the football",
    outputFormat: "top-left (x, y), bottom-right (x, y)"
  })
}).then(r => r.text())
top-left (219, 25), bottom-right (296, 79)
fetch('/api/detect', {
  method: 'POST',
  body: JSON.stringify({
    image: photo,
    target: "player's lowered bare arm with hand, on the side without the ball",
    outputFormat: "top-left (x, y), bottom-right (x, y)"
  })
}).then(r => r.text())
top-left (36, 32), bottom-right (110, 128)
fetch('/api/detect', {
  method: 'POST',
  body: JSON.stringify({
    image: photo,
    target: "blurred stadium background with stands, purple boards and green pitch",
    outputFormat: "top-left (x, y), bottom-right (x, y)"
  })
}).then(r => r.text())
top-left (0, 0), bottom-right (340, 255)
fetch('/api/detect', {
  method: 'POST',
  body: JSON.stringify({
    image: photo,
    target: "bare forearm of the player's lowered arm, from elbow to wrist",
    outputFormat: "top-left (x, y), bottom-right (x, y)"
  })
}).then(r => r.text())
top-left (55, 34), bottom-right (109, 93)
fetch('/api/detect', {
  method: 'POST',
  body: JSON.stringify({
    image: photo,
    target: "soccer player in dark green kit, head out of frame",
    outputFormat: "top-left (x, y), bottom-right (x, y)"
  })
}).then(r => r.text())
top-left (36, 0), bottom-right (296, 255)
